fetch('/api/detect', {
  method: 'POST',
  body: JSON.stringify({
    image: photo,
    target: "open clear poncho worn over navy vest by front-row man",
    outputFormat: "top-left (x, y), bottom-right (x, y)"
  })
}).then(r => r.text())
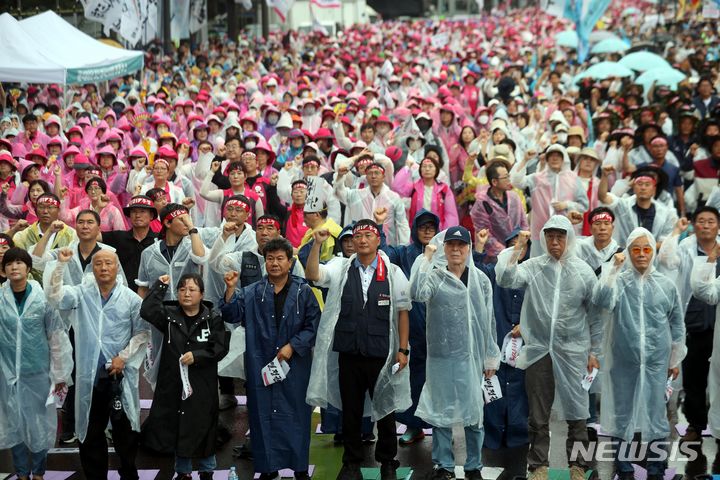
top-left (305, 251), bottom-right (412, 421)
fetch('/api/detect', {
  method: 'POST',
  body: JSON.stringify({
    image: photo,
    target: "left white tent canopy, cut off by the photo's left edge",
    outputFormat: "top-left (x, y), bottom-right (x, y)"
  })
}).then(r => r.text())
top-left (0, 13), bottom-right (65, 83)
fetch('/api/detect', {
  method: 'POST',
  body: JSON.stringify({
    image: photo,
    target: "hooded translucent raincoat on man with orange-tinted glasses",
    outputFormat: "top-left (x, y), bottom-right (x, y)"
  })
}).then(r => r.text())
top-left (593, 228), bottom-right (686, 442)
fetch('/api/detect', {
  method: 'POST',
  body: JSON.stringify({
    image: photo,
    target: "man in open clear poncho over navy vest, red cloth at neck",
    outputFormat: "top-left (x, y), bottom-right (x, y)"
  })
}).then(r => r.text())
top-left (305, 219), bottom-right (412, 480)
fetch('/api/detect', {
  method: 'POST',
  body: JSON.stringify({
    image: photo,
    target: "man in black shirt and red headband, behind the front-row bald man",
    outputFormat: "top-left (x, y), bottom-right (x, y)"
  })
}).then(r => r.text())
top-left (101, 195), bottom-right (157, 293)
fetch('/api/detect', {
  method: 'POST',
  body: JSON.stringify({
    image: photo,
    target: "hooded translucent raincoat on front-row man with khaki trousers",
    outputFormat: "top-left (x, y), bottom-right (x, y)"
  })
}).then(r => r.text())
top-left (495, 215), bottom-right (602, 420)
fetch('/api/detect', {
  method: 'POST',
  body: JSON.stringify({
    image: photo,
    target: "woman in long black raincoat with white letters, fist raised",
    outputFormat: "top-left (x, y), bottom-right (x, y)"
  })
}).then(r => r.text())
top-left (140, 274), bottom-right (229, 480)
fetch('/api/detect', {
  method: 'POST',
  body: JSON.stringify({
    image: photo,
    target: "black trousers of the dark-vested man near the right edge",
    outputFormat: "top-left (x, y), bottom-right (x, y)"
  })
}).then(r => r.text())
top-left (683, 330), bottom-right (713, 433)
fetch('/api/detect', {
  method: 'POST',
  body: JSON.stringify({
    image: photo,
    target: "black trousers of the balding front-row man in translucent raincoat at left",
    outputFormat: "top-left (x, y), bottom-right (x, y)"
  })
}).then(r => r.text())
top-left (80, 378), bottom-right (140, 480)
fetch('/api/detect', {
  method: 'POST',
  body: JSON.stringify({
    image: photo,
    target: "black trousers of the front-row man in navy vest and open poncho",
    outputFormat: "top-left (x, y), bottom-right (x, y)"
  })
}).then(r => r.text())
top-left (338, 353), bottom-right (397, 463)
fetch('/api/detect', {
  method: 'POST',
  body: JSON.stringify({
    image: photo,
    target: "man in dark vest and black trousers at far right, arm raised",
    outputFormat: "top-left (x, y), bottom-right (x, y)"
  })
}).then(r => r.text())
top-left (658, 206), bottom-right (720, 448)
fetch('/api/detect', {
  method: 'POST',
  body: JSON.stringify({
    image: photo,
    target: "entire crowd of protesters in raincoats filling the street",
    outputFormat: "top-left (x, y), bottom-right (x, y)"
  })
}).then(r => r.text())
top-left (0, 2), bottom-right (720, 480)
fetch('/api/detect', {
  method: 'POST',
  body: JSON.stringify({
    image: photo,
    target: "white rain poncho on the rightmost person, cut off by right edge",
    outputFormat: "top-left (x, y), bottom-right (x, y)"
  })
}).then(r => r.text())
top-left (690, 257), bottom-right (720, 439)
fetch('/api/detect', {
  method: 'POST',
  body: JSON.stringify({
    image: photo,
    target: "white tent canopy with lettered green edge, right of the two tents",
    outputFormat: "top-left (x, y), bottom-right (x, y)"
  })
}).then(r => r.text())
top-left (19, 10), bottom-right (144, 84)
